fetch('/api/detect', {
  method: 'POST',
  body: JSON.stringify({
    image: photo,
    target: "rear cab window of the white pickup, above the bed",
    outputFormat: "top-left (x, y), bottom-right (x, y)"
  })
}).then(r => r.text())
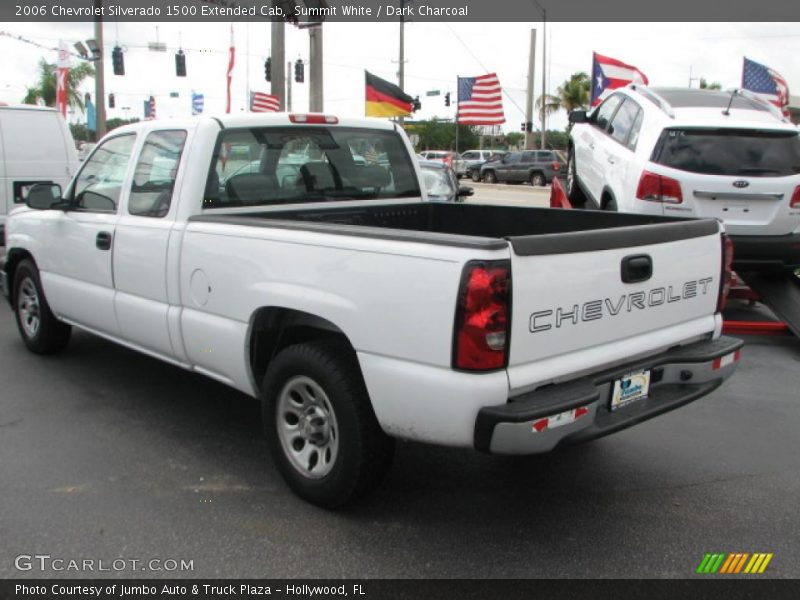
top-left (203, 127), bottom-right (421, 208)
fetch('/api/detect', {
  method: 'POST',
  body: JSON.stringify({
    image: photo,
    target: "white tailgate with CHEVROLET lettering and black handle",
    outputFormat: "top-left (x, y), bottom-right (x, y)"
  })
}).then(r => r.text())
top-left (508, 220), bottom-right (722, 389)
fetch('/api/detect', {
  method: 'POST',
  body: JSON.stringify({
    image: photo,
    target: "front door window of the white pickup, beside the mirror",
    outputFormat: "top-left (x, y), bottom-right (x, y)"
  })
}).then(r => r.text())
top-left (73, 133), bottom-right (136, 212)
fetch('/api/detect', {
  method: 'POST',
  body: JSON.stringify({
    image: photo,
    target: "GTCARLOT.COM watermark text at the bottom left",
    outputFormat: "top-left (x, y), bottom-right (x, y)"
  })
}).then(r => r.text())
top-left (14, 554), bottom-right (194, 573)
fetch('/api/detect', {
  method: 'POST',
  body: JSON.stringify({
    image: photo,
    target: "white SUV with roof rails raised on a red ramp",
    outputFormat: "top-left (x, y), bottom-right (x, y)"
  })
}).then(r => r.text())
top-left (567, 85), bottom-right (800, 270)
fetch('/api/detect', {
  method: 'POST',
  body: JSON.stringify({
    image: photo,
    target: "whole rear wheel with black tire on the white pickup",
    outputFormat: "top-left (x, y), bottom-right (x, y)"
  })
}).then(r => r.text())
top-left (261, 341), bottom-right (394, 508)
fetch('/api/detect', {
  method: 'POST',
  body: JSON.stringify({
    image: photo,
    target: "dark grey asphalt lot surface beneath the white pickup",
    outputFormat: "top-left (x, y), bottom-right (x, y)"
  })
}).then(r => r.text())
top-left (0, 305), bottom-right (800, 578)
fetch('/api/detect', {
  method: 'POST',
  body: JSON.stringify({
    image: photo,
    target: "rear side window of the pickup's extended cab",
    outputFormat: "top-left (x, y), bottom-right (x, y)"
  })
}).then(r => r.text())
top-left (128, 130), bottom-right (186, 218)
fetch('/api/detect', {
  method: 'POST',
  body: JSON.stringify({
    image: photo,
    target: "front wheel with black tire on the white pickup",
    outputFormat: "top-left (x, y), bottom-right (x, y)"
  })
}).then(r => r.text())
top-left (11, 258), bottom-right (72, 354)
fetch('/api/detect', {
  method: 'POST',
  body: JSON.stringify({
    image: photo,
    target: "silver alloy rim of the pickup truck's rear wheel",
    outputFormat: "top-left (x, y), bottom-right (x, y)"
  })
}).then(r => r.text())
top-left (276, 375), bottom-right (339, 479)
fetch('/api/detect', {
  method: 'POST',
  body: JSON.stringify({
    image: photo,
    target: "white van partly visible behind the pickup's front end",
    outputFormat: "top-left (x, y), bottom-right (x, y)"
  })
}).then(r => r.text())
top-left (0, 105), bottom-right (78, 243)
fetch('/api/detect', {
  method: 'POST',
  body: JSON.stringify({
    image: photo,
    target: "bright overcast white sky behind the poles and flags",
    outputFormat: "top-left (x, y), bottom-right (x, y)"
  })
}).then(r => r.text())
top-left (0, 21), bottom-right (800, 131)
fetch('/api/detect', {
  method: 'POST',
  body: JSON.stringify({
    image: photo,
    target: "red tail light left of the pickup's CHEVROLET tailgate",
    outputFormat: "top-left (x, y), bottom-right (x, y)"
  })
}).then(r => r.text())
top-left (453, 261), bottom-right (511, 371)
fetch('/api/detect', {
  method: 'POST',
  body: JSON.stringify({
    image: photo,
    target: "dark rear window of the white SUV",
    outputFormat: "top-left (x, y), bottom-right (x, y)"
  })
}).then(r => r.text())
top-left (651, 129), bottom-right (800, 177)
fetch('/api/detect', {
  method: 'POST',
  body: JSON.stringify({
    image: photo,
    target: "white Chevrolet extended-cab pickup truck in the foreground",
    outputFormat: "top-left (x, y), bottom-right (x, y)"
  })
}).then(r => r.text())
top-left (0, 114), bottom-right (741, 506)
